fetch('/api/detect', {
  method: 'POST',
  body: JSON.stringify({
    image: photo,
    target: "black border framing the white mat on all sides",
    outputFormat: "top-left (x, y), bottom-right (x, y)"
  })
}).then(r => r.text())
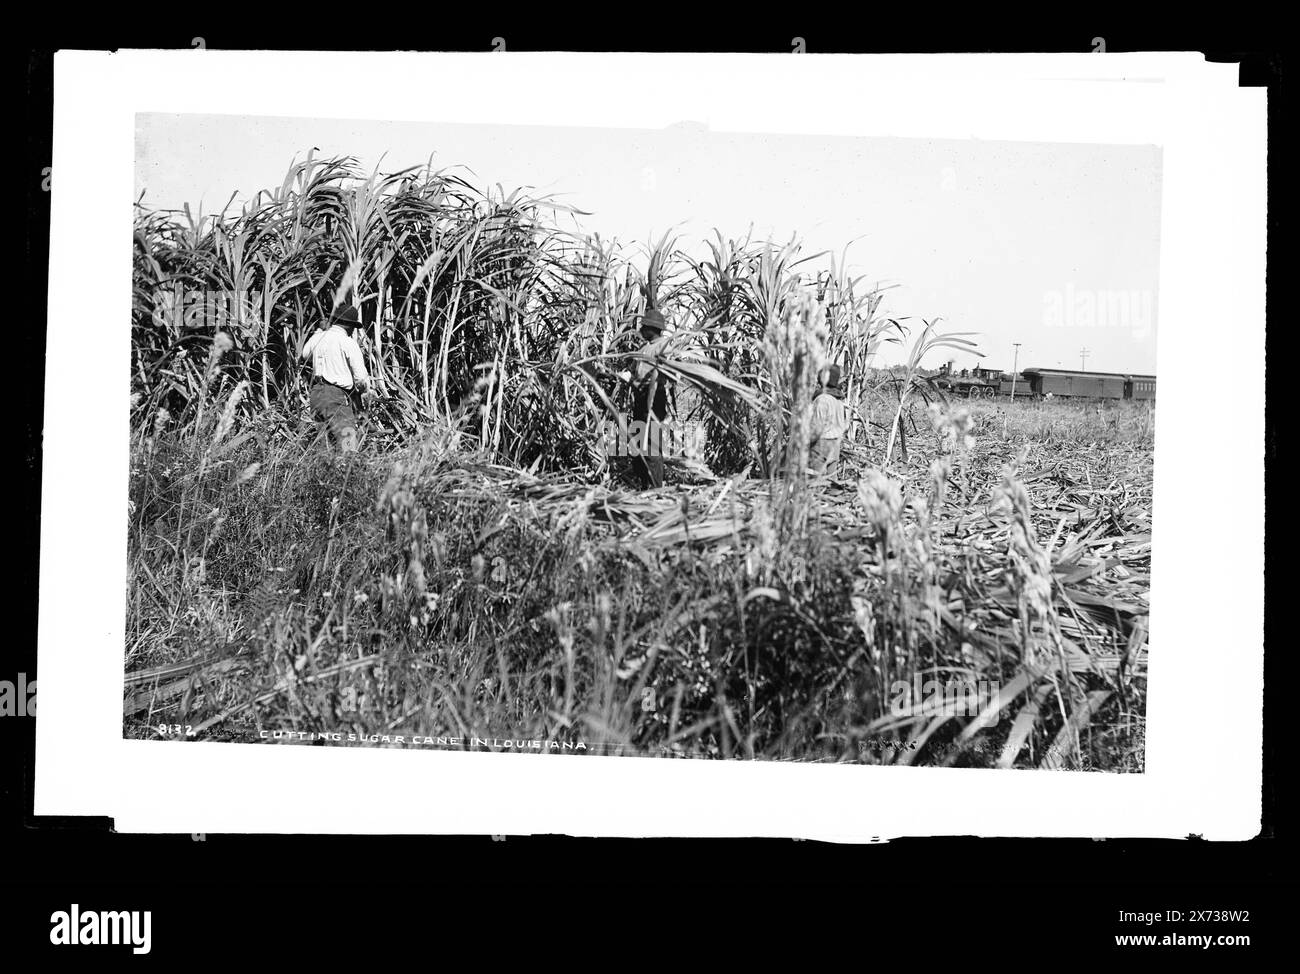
top-left (10, 20), bottom-right (1295, 962)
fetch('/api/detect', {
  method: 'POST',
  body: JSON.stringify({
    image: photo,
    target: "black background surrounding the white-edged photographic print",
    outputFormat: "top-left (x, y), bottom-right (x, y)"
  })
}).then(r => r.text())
top-left (0, 15), bottom-right (1296, 966)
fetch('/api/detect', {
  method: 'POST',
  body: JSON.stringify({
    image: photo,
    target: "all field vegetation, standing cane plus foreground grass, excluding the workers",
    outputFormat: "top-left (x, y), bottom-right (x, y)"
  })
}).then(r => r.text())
top-left (127, 156), bottom-right (1149, 767)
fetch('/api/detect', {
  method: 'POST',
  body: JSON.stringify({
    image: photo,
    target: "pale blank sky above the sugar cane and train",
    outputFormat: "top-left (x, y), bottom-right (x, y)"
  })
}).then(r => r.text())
top-left (135, 114), bottom-right (1161, 373)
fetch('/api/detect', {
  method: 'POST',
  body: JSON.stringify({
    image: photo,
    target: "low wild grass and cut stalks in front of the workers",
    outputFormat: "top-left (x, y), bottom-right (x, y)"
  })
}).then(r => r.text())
top-left (127, 395), bottom-right (1144, 767)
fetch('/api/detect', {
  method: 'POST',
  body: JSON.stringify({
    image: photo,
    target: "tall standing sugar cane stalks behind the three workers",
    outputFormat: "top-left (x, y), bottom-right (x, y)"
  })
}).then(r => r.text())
top-left (133, 155), bottom-right (898, 473)
